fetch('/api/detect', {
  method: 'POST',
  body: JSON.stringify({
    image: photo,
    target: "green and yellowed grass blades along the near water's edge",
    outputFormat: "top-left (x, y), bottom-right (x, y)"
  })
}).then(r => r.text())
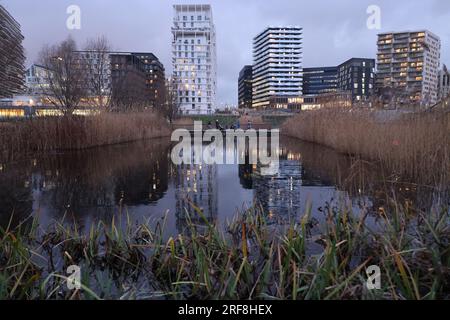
top-left (0, 203), bottom-right (450, 300)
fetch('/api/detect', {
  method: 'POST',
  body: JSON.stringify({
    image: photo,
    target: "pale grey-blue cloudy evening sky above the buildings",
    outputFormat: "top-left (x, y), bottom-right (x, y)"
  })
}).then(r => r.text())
top-left (0, 0), bottom-right (450, 104)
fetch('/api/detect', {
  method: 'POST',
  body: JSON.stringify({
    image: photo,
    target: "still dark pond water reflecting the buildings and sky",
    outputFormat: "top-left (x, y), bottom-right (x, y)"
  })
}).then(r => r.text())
top-left (0, 137), bottom-right (443, 233)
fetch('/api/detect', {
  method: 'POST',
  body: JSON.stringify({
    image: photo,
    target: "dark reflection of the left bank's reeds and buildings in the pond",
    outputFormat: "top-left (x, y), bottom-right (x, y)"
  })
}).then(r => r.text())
top-left (0, 140), bottom-right (169, 225)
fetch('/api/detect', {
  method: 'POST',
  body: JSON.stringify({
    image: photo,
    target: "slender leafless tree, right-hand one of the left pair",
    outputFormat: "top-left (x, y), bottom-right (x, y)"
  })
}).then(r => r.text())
top-left (84, 36), bottom-right (112, 109)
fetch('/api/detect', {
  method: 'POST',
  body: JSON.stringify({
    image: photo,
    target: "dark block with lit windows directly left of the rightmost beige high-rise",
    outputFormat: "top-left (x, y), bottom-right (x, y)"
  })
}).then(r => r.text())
top-left (337, 58), bottom-right (375, 101)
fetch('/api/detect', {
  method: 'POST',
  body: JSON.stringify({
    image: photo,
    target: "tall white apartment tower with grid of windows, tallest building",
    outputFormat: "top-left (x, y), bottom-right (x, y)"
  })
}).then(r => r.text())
top-left (172, 4), bottom-right (217, 114)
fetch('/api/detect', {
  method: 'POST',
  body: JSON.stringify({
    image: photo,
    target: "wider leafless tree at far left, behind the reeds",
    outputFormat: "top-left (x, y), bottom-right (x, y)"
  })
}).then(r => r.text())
top-left (40, 37), bottom-right (85, 115)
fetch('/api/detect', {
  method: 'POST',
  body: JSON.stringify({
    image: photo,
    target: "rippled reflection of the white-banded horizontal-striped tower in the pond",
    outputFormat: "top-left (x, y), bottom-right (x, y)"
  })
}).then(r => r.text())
top-left (254, 150), bottom-right (302, 222)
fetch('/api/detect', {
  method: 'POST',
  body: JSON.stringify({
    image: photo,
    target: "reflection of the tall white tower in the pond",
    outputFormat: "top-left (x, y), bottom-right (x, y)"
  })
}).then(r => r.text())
top-left (175, 164), bottom-right (218, 233)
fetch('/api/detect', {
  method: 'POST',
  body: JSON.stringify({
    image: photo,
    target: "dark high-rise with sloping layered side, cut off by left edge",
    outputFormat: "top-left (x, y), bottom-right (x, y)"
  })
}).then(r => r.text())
top-left (0, 5), bottom-right (25, 98)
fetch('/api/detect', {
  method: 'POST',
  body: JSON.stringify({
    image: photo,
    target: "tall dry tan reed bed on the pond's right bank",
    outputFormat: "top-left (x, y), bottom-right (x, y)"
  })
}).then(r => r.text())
top-left (282, 108), bottom-right (450, 185)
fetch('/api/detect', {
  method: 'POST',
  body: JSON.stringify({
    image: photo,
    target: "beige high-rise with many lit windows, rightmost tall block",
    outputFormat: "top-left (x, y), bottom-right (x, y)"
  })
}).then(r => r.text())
top-left (376, 30), bottom-right (441, 106)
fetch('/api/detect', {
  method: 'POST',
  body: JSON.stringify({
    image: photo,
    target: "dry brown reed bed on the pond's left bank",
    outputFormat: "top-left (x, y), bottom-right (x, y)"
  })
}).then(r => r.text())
top-left (0, 112), bottom-right (170, 160)
